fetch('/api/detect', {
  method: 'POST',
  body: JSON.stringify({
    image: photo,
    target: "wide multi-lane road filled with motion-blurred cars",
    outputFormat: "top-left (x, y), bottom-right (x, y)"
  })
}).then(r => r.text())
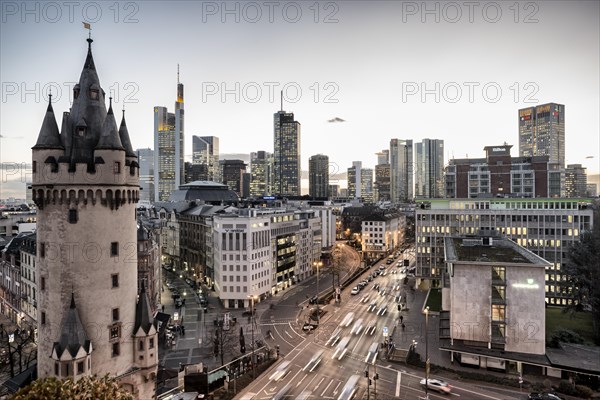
top-left (237, 250), bottom-right (522, 400)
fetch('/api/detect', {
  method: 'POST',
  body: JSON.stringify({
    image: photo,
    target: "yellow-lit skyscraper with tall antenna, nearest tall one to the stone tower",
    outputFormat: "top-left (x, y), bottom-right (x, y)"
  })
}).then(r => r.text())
top-left (154, 65), bottom-right (185, 201)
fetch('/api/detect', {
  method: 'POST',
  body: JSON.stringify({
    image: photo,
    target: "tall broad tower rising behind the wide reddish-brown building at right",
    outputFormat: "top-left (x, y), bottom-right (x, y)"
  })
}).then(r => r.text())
top-left (519, 103), bottom-right (565, 168)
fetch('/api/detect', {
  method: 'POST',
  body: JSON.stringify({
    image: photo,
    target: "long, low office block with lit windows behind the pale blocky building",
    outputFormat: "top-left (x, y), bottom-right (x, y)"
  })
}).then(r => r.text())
top-left (415, 198), bottom-right (593, 305)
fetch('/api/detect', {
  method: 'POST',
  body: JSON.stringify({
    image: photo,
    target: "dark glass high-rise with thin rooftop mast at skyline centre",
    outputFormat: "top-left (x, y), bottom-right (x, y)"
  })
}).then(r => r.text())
top-left (273, 110), bottom-right (301, 196)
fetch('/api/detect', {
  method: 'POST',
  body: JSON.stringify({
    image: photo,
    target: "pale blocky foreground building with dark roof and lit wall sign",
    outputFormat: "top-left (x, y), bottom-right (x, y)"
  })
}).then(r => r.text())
top-left (440, 236), bottom-right (551, 375)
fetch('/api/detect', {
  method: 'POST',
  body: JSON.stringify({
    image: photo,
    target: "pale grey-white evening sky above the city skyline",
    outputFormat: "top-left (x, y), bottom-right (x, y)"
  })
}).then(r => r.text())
top-left (0, 1), bottom-right (600, 198)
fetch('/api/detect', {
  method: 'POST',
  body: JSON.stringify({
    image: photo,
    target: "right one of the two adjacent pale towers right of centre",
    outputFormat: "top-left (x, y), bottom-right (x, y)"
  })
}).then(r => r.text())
top-left (415, 139), bottom-right (444, 198)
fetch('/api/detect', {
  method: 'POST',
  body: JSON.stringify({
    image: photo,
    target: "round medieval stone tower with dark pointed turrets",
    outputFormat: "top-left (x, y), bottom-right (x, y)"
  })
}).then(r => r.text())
top-left (32, 39), bottom-right (158, 399)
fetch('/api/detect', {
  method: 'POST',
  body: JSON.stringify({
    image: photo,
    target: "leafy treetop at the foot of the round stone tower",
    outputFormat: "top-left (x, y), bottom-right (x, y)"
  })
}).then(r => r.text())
top-left (12, 375), bottom-right (133, 400)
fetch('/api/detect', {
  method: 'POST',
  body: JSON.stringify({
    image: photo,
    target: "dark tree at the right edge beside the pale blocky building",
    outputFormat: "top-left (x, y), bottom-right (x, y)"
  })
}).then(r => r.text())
top-left (563, 205), bottom-right (600, 344)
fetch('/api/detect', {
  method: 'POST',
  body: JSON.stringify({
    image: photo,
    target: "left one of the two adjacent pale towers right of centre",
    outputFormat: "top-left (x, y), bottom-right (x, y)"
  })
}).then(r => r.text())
top-left (390, 139), bottom-right (413, 203)
